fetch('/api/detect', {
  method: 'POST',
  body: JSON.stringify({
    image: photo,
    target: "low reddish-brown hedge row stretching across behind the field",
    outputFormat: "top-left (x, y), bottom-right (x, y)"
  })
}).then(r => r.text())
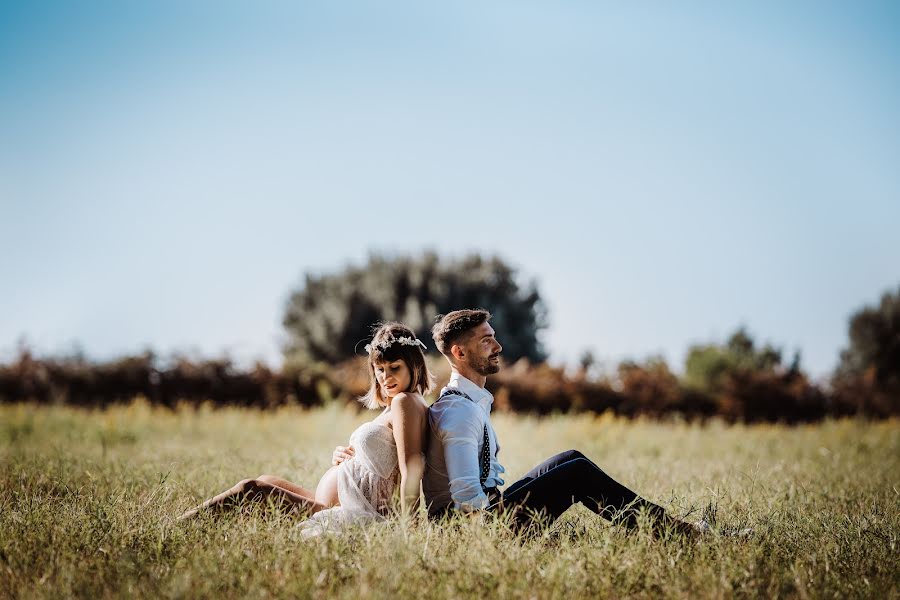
top-left (0, 351), bottom-right (900, 423)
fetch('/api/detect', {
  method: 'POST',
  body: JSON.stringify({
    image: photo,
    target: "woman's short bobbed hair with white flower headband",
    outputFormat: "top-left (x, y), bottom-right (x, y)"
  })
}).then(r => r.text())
top-left (359, 321), bottom-right (434, 408)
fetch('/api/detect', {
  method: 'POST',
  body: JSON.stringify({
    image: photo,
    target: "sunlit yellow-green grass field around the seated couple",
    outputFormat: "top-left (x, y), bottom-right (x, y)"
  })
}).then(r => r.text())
top-left (0, 402), bottom-right (900, 600)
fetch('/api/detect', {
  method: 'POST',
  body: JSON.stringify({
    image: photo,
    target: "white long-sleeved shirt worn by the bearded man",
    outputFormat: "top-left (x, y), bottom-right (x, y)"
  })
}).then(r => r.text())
top-left (422, 371), bottom-right (506, 514)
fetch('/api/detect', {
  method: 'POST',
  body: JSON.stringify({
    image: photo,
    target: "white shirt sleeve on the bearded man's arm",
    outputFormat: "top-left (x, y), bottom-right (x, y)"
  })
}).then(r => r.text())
top-left (431, 398), bottom-right (488, 512)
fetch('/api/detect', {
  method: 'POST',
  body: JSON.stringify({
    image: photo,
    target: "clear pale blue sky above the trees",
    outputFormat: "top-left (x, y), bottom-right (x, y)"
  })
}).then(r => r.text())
top-left (0, 0), bottom-right (900, 378)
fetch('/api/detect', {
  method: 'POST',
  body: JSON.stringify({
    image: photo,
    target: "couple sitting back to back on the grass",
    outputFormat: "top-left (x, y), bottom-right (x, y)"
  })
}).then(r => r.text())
top-left (181, 310), bottom-right (708, 535)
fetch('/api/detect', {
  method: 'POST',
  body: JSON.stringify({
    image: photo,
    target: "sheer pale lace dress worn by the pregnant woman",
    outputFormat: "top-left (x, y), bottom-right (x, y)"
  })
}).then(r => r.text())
top-left (300, 422), bottom-right (400, 537)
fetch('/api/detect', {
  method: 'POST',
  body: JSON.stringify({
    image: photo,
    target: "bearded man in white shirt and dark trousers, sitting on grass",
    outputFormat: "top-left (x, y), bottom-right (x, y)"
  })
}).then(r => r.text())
top-left (422, 310), bottom-right (697, 534)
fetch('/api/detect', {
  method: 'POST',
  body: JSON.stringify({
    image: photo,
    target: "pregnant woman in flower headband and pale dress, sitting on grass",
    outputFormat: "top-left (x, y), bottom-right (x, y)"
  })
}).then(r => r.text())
top-left (180, 322), bottom-right (433, 535)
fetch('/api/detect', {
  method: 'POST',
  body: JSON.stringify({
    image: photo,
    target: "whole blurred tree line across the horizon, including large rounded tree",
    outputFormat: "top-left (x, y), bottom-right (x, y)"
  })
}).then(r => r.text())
top-left (0, 253), bottom-right (900, 422)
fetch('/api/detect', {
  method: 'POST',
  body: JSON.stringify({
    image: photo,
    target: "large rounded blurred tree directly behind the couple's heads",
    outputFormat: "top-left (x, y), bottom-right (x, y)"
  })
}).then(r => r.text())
top-left (283, 252), bottom-right (547, 362)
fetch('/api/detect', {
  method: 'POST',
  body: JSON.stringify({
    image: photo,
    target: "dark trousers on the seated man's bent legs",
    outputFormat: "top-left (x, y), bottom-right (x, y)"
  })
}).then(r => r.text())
top-left (491, 450), bottom-right (665, 527)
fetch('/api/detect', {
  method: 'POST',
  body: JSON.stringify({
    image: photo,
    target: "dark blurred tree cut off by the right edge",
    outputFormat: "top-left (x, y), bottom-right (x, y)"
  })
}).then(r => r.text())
top-left (833, 287), bottom-right (900, 414)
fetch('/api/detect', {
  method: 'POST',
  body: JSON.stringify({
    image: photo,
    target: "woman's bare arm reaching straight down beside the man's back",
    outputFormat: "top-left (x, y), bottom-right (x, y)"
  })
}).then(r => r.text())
top-left (391, 393), bottom-right (425, 514)
